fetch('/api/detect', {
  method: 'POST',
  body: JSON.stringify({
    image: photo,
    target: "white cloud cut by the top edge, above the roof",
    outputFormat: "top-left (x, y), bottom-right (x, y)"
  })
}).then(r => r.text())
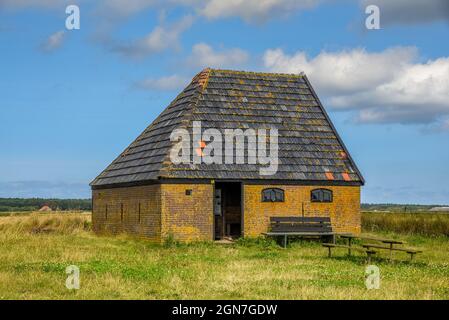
top-left (200, 0), bottom-right (319, 21)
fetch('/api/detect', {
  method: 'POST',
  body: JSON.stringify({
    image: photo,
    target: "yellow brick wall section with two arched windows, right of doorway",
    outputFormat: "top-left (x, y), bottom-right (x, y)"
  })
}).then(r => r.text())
top-left (243, 185), bottom-right (361, 237)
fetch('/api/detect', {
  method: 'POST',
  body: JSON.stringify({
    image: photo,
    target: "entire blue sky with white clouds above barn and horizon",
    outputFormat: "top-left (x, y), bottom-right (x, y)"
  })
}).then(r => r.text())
top-left (0, 0), bottom-right (449, 204)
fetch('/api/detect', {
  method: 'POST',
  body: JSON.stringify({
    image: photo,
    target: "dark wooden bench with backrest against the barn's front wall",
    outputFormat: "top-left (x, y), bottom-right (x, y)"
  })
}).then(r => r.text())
top-left (264, 217), bottom-right (336, 248)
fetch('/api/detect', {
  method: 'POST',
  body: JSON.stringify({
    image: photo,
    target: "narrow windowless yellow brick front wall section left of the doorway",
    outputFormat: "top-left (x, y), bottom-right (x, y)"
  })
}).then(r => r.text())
top-left (161, 184), bottom-right (214, 242)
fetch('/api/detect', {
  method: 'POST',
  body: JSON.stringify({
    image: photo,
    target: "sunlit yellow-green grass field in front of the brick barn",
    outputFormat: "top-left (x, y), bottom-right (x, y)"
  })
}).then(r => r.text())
top-left (0, 213), bottom-right (449, 299)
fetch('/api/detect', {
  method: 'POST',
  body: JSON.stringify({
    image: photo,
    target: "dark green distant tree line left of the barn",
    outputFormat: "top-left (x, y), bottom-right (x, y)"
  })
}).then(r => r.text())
top-left (0, 198), bottom-right (92, 212)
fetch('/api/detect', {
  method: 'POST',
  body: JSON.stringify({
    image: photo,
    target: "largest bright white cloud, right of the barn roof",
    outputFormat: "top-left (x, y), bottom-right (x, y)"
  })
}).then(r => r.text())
top-left (264, 47), bottom-right (449, 124)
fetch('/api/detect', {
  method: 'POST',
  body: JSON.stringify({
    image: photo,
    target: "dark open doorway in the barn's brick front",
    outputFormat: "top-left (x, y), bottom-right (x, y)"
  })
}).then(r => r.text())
top-left (214, 182), bottom-right (242, 240)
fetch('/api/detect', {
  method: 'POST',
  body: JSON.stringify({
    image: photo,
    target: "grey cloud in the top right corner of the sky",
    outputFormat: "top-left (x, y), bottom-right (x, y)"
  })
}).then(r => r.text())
top-left (360, 0), bottom-right (449, 25)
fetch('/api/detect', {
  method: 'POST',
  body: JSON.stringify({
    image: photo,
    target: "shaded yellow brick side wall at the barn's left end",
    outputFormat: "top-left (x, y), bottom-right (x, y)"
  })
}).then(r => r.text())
top-left (92, 185), bottom-right (161, 242)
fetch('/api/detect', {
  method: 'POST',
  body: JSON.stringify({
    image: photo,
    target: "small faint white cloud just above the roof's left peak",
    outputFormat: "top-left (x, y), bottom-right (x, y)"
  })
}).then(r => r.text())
top-left (187, 43), bottom-right (249, 68)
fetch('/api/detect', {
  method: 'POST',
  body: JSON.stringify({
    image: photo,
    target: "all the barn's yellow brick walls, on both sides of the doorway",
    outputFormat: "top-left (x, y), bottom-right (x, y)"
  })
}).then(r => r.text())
top-left (92, 184), bottom-right (360, 242)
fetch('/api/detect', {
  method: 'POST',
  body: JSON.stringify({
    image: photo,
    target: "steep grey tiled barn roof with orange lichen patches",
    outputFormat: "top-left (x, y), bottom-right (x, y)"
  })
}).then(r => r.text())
top-left (91, 69), bottom-right (364, 187)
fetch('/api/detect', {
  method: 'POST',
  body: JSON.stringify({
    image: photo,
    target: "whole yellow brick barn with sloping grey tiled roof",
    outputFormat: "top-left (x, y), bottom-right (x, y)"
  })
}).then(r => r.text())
top-left (90, 68), bottom-right (364, 242)
